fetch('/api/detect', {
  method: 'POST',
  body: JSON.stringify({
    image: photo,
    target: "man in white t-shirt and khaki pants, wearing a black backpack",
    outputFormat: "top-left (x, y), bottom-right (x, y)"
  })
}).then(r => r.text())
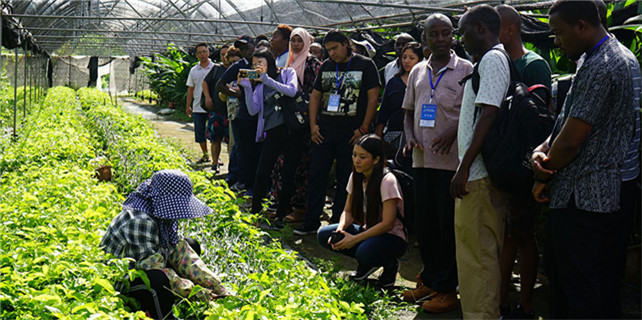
top-left (450, 5), bottom-right (510, 319)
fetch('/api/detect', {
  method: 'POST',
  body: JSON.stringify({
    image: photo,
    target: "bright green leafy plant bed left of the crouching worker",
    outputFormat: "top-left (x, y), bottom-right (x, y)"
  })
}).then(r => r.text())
top-left (0, 87), bottom-right (144, 319)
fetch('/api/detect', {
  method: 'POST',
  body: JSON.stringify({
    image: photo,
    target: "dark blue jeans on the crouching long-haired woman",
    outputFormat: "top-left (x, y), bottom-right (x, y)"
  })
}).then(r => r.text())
top-left (317, 224), bottom-right (408, 267)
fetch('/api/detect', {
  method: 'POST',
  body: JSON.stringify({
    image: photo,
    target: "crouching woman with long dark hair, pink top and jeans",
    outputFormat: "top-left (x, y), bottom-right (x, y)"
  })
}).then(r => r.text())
top-left (317, 134), bottom-right (408, 288)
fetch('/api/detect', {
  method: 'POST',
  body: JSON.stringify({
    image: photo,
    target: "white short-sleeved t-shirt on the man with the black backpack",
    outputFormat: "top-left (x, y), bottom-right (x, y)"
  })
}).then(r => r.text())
top-left (457, 44), bottom-right (510, 181)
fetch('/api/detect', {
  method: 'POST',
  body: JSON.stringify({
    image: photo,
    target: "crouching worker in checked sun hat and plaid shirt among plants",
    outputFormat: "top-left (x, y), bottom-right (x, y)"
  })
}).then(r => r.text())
top-left (100, 170), bottom-right (227, 319)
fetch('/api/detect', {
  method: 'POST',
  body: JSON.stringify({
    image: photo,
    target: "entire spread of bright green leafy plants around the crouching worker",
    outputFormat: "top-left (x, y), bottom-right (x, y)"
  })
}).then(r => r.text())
top-left (0, 88), bottom-right (398, 319)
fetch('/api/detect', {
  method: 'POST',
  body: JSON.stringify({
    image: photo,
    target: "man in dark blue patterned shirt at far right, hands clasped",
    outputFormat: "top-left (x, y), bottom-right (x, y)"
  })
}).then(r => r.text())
top-left (532, 0), bottom-right (635, 318)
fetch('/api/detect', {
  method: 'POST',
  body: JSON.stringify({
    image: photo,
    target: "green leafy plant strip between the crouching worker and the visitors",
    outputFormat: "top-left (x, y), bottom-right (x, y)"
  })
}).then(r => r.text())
top-left (80, 89), bottom-right (399, 319)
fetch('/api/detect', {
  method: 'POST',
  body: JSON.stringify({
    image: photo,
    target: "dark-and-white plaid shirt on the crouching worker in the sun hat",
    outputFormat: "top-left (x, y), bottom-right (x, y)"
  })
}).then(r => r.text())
top-left (100, 209), bottom-right (160, 261)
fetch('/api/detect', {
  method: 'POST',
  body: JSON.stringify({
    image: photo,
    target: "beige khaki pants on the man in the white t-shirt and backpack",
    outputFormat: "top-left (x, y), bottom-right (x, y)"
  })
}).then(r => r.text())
top-left (455, 178), bottom-right (508, 319)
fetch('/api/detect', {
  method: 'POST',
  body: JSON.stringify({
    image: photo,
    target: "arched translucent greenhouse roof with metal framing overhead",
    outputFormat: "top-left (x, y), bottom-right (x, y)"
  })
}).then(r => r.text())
top-left (2, 0), bottom-right (550, 56)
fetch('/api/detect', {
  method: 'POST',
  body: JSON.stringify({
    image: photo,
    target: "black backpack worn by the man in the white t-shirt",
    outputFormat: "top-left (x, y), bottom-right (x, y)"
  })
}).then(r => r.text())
top-left (462, 48), bottom-right (555, 196)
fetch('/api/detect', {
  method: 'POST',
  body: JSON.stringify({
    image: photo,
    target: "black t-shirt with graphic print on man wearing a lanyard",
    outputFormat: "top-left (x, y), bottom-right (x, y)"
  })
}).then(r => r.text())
top-left (314, 54), bottom-right (380, 129)
